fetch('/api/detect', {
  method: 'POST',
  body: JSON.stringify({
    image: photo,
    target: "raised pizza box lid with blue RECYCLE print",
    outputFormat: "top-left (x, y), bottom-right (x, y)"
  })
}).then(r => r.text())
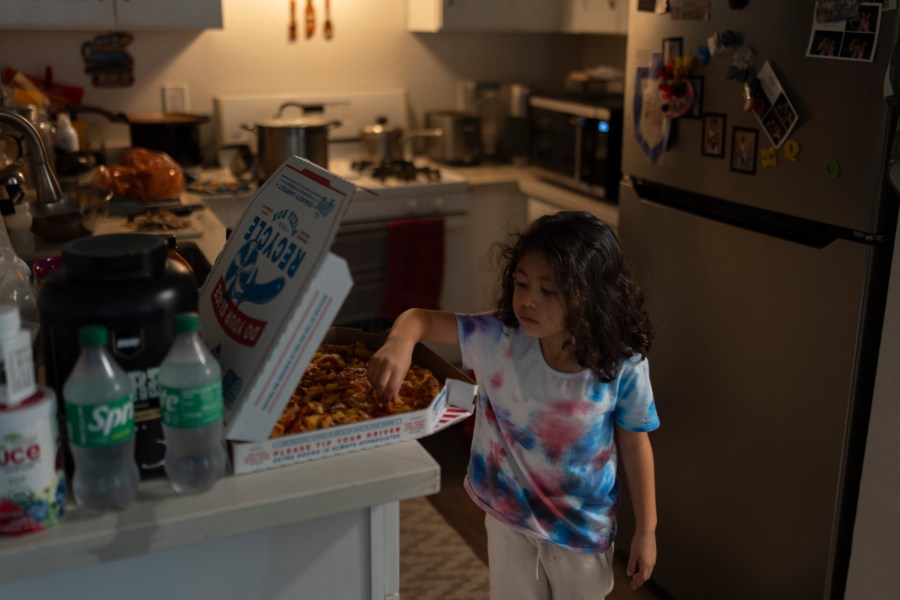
top-left (198, 156), bottom-right (356, 441)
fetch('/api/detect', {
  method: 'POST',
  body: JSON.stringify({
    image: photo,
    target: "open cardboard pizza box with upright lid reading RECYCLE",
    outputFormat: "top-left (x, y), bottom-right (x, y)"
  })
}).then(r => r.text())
top-left (198, 156), bottom-right (476, 474)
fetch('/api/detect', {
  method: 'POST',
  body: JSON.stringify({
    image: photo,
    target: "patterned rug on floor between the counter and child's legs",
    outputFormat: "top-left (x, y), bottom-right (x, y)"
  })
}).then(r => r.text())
top-left (400, 498), bottom-right (488, 600)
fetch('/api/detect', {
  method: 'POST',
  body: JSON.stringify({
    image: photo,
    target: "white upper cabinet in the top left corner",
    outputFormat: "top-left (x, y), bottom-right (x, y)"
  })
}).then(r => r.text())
top-left (0, 0), bottom-right (222, 31)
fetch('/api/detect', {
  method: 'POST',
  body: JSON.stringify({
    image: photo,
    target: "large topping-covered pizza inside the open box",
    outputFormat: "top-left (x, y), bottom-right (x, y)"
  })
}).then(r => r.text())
top-left (270, 340), bottom-right (441, 438)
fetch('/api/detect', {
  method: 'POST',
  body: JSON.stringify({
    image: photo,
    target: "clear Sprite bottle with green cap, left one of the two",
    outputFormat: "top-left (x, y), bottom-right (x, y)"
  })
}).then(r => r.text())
top-left (63, 325), bottom-right (140, 512)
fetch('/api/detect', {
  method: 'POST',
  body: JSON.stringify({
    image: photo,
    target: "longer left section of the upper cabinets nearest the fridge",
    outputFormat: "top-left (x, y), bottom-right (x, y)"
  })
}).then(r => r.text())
top-left (406, 0), bottom-right (562, 32)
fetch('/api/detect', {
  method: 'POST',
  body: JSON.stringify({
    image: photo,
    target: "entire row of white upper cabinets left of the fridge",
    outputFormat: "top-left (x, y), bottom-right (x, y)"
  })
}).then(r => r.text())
top-left (406, 0), bottom-right (628, 35)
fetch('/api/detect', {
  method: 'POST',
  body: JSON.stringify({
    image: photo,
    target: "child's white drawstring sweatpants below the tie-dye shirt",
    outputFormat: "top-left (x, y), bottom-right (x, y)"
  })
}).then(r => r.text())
top-left (484, 515), bottom-right (613, 600)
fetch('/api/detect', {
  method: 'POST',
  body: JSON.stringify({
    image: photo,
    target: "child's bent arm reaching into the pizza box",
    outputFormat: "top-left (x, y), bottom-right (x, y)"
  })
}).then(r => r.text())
top-left (367, 308), bottom-right (459, 399)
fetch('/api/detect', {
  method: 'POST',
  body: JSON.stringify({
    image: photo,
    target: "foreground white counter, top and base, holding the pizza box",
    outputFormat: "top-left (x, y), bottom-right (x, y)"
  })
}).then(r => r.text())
top-left (0, 442), bottom-right (440, 600)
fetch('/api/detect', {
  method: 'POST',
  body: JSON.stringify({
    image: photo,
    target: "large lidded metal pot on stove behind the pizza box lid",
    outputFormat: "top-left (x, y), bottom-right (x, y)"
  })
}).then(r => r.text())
top-left (242, 102), bottom-right (341, 181)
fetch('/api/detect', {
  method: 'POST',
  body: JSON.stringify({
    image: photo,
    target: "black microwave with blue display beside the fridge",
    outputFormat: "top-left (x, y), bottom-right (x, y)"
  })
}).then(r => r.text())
top-left (529, 96), bottom-right (623, 201)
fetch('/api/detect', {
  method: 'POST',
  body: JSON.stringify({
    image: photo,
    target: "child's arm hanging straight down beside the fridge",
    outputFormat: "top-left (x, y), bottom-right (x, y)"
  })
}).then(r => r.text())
top-left (616, 426), bottom-right (656, 589)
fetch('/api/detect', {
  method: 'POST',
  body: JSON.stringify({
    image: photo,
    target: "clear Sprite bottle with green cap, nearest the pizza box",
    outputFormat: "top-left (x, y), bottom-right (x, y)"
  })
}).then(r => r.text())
top-left (159, 312), bottom-right (226, 493)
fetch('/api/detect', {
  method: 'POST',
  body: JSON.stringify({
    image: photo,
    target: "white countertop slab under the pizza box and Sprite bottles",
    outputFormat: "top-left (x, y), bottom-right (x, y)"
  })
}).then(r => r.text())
top-left (0, 441), bottom-right (440, 583)
